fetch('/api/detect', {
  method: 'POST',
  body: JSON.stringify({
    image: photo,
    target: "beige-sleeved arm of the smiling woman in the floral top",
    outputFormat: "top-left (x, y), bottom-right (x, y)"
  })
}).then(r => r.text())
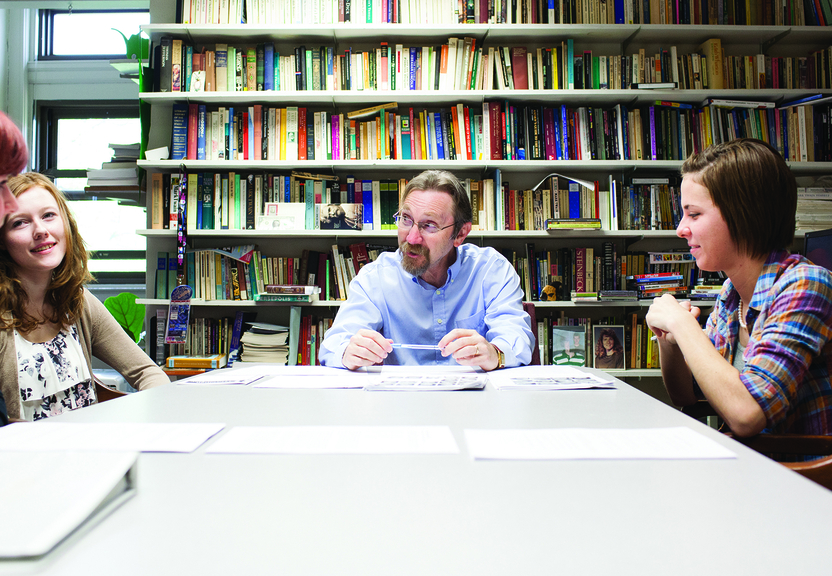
top-left (85, 292), bottom-right (170, 390)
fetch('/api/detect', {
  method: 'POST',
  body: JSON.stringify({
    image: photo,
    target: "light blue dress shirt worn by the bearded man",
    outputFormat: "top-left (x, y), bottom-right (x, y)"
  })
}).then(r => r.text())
top-left (320, 244), bottom-right (534, 368)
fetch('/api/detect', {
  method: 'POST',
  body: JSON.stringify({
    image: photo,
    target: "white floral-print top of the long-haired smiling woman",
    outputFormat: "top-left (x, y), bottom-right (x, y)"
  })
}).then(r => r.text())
top-left (14, 326), bottom-right (96, 421)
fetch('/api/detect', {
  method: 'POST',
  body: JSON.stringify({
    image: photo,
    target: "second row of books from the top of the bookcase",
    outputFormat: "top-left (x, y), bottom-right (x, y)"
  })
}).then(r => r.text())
top-left (154, 36), bottom-right (832, 92)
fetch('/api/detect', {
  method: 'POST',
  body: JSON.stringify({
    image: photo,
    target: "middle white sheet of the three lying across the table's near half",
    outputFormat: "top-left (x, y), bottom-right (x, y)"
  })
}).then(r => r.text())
top-left (205, 426), bottom-right (459, 454)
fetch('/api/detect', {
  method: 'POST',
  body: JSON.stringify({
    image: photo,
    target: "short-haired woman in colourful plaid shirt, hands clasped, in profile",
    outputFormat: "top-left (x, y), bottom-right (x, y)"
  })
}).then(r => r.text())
top-left (647, 138), bottom-right (832, 448)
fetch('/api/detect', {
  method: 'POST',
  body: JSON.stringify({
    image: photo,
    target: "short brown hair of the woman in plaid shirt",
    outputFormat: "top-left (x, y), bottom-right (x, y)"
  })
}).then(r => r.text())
top-left (682, 138), bottom-right (797, 258)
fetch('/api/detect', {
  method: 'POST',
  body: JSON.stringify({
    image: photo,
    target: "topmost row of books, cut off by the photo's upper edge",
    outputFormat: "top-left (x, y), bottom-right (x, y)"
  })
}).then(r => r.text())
top-left (177, 0), bottom-right (832, 26)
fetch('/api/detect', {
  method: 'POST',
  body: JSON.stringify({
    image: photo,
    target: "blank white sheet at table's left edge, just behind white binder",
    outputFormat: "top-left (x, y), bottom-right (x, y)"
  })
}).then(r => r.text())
top-left (0, 422), bottom-right (225, 453)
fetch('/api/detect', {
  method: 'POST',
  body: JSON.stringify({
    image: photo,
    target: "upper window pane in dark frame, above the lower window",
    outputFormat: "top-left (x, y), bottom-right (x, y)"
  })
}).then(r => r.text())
top-left (38, 10), bottom-right (150, 60)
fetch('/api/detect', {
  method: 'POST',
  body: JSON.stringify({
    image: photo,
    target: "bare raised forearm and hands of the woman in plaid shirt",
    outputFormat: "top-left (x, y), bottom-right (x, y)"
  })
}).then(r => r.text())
top-left (647, 295), bottom-right (766, 436)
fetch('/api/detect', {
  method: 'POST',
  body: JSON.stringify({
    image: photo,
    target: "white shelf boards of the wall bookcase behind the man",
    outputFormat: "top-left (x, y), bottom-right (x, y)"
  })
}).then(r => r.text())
top-left (139, 0), bottom-right (832, 379)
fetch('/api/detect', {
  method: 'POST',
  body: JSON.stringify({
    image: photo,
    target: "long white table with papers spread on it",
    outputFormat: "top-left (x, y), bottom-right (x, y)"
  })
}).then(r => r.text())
top-left (0, 368), bottom-right (832, 576)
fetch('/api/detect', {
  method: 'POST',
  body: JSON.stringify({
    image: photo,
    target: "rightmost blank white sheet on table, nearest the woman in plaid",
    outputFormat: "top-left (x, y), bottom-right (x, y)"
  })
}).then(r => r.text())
top-left (465, 427), bottom-right (737, 460)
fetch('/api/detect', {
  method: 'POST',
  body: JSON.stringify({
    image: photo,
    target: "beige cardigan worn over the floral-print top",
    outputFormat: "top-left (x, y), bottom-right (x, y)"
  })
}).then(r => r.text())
top-left (0, 289), bottom-right (170, 419)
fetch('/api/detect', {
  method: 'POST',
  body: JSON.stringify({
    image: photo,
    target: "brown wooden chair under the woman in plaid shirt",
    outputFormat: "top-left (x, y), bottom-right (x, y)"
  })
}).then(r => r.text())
top-left (682, 401), bottom-right (832, 490)
